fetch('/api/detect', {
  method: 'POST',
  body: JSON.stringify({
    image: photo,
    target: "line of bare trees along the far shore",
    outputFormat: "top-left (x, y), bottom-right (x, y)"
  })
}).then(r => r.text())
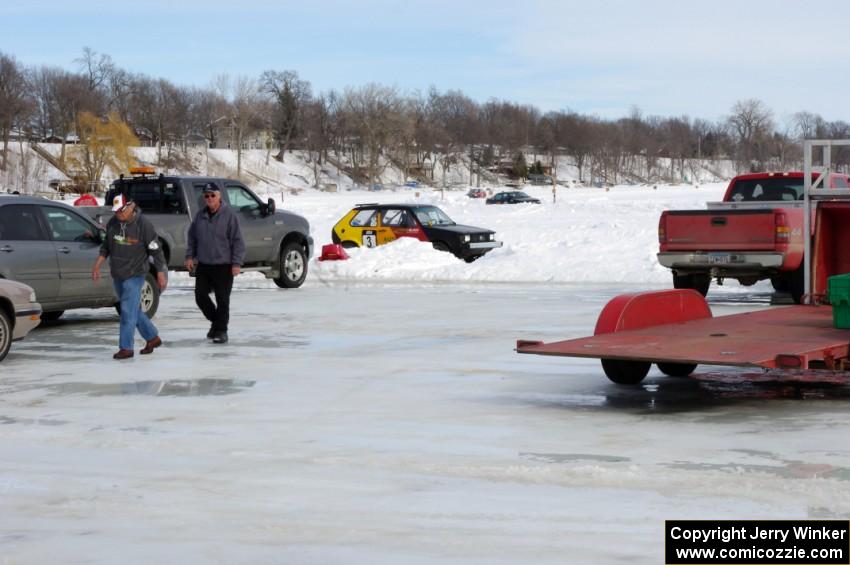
top-left (0, 48), bottom-right (850, 187)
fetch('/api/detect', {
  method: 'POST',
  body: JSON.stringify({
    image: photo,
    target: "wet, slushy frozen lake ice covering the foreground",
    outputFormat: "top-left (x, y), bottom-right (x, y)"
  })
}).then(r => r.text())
top-left (0, 279), bottom-right (850, 563)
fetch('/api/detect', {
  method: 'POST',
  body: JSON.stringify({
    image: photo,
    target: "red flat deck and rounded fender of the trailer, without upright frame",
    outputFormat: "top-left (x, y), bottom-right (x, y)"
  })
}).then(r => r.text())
top-left (517, 290), bottom-right (850, 384)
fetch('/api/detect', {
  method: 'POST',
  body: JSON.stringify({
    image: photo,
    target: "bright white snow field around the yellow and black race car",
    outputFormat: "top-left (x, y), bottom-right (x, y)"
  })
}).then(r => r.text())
top-left (184, 183), bottom-right (756, 292)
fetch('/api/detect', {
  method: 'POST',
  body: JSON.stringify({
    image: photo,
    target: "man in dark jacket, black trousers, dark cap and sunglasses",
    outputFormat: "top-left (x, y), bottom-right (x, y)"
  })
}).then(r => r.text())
top-left (185, 183), bottom-right (245, 343)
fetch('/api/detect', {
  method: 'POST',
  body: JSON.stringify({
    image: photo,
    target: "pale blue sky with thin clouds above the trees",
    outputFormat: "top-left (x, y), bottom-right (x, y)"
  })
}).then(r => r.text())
top-left (0, 0), bottom-right (850, 123)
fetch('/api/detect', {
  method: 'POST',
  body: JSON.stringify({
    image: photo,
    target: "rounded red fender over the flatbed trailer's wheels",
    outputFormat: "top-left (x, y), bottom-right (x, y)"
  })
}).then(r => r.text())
top-left (593, 289), bottom-right (712, 335)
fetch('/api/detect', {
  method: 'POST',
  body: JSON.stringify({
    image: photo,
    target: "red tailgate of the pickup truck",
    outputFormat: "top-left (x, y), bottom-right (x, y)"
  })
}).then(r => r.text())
top-left (665, 209), bottom-right (776, 251)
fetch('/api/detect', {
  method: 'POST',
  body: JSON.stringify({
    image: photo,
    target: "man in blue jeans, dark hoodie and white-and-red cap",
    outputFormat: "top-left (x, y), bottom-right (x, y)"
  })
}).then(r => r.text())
top-left (92, 195), bottom-right (168, 359)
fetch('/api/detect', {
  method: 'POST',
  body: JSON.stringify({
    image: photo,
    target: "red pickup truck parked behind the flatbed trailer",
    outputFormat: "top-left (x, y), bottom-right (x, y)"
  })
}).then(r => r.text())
top-left (658, 172), bottom-right (850, 303)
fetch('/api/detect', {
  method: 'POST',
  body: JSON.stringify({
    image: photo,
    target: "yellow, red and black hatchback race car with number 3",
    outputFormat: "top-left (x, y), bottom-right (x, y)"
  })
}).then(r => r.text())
top-left (331, 204), bottom-right (502, 263)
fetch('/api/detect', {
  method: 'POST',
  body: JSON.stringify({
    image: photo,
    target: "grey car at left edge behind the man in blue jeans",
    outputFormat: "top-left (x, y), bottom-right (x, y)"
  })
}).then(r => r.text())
top-left (0, 195), bottom-right (159, 320)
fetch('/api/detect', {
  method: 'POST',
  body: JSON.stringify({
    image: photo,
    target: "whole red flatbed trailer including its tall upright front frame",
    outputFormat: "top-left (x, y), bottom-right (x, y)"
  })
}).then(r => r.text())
top-left (516, 140), bottom-right (850, 384)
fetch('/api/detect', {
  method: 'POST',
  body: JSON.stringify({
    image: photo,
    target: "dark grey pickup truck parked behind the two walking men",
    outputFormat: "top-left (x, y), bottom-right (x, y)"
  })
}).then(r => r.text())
top-left (83, 167), bottom-right (313, 288)
